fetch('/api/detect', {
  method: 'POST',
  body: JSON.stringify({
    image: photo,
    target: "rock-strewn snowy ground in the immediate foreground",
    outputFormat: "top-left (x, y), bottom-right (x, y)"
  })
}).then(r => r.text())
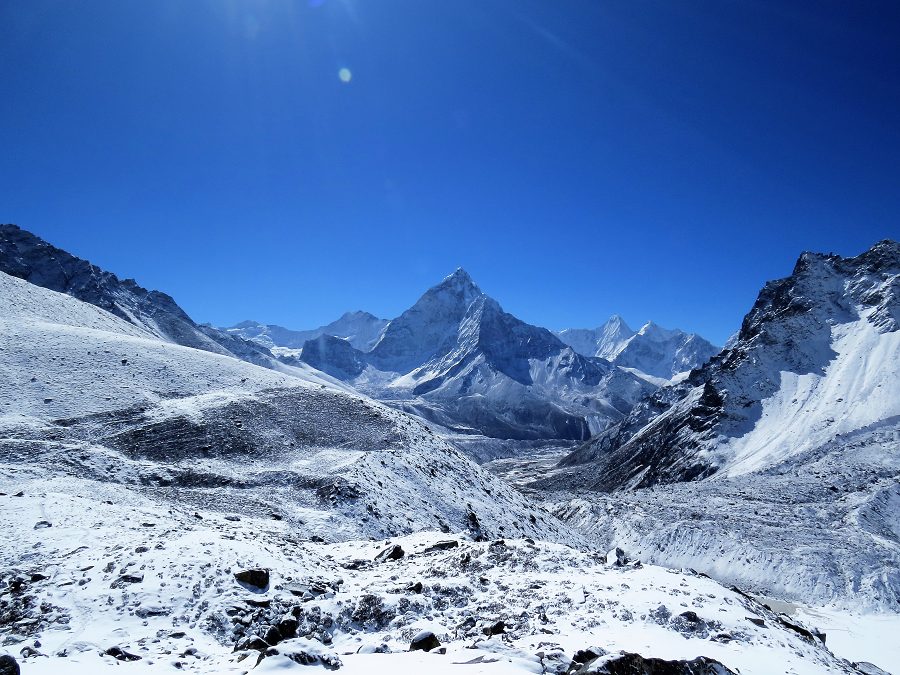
top-left (0, 486), bottom-right (864, 675)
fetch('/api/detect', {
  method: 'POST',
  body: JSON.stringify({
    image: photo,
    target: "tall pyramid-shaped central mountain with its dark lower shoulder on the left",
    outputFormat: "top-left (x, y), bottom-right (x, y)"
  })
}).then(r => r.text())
top-left (299, 269), bottom-right (655, 440)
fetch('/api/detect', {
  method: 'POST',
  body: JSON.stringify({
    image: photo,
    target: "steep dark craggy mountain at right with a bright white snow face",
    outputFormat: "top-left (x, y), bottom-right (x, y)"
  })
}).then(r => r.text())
top-left (563, 240), bottom-right (900, 490)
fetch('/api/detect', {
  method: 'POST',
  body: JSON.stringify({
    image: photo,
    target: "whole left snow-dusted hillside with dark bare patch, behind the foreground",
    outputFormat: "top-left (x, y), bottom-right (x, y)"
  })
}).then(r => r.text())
top-left (0, 266), bottom-right (578, 543)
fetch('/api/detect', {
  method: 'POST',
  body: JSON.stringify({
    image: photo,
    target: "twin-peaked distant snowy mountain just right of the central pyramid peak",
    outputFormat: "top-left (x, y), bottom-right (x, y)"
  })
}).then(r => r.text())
top-left (556, 315), bottom-right (720, 380)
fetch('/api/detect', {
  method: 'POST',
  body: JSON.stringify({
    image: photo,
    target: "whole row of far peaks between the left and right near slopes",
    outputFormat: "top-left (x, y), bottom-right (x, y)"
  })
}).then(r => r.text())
top-left (221, 269), bottom-right (718, 440)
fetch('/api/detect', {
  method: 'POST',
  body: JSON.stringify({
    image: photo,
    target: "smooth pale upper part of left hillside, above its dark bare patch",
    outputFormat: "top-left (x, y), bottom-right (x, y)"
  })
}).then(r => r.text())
top-left (0, 273), bottom-right (346, 419)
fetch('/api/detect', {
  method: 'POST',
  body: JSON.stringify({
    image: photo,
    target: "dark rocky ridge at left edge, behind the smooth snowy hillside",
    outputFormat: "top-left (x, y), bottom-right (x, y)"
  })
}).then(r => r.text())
top-left (0, 224), bottom-right (278, 368)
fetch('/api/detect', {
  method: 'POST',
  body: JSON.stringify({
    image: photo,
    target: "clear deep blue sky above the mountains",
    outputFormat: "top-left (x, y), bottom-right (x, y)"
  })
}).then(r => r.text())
top-left (0, 0), bottom-right (900, 344)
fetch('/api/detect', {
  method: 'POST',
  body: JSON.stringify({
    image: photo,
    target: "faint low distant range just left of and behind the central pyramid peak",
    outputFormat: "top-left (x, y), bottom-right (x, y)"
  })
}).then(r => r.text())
top-left (225, 311), bottom-right (388, 352)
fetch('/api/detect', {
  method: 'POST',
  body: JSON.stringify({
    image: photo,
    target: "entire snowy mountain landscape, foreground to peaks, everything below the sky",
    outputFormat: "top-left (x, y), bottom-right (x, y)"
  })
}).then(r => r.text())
top-left (0, 225), bottom-right (900, 675)
